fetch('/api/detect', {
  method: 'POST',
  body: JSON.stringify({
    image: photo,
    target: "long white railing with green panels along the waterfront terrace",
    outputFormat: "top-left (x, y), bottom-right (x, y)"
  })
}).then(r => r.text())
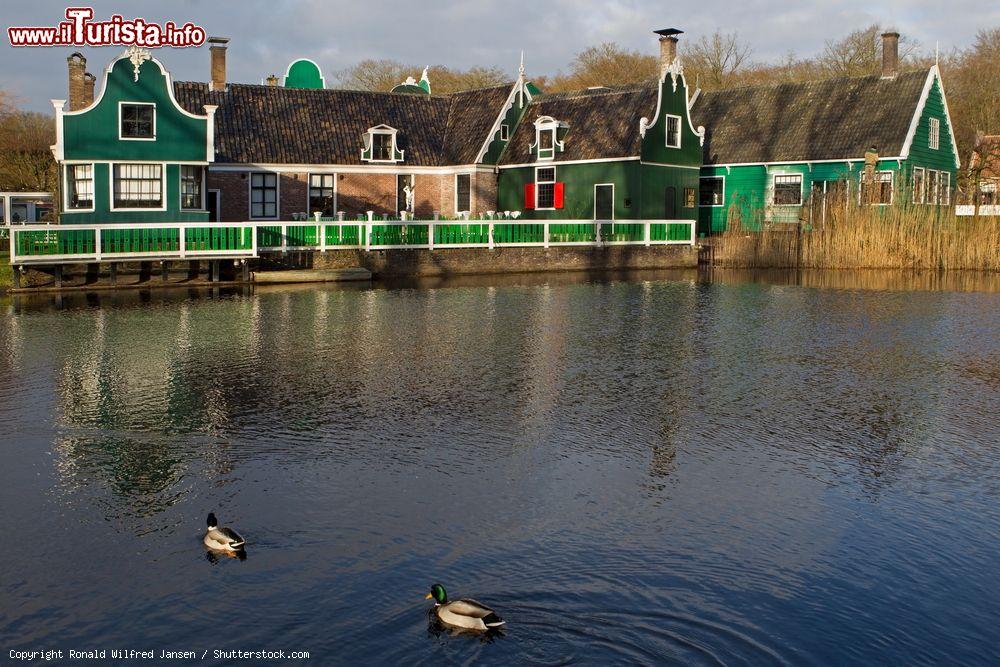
top-left (6, 216), bottom-right (696, 264)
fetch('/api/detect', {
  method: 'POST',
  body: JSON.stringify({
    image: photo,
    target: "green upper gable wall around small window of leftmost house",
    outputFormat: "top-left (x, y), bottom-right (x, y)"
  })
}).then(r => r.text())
top-left (63, 59), bottom-right (208, 162)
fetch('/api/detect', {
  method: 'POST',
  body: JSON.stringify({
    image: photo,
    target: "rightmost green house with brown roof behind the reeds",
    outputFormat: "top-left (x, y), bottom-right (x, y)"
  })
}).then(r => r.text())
top-left (691, 33), bottom-right (959, 232)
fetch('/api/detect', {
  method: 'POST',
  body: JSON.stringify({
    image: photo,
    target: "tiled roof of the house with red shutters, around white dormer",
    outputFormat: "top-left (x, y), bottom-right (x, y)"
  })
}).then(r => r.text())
top-left (501, 85), bottom-right (657, 164)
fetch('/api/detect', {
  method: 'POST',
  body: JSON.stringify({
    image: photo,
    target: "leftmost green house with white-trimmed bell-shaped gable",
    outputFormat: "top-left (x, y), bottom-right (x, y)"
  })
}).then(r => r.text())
top-left (53, 48), bottom-right (215, 224)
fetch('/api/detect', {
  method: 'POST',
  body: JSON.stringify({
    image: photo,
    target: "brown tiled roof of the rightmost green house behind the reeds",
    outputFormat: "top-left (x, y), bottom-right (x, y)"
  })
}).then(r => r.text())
top-left (691, 70), bottom-right (927, 164)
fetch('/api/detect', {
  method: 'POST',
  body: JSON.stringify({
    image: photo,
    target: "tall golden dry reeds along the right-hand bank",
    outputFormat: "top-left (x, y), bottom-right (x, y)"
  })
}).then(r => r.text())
top-left (714, 206), bottom-right (1000, 271)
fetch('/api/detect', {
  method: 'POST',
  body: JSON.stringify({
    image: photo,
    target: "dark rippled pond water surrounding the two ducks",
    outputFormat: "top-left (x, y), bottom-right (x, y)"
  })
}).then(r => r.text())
top-left (0, 276), bottom-right (1000, 665)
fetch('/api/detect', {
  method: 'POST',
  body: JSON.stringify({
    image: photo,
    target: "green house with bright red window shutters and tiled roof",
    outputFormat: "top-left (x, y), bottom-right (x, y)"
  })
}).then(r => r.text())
top-left (497, 52), bottom-right (703, 226)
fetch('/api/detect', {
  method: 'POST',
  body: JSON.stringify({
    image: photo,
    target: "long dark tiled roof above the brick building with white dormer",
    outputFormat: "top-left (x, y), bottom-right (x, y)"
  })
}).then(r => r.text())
top-left (174, 81), bottom-right (511, 166)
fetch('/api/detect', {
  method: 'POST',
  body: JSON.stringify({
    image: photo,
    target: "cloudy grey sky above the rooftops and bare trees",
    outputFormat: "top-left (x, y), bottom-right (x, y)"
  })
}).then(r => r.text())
top-left (0, 0), bottom-right (1000, 111)
